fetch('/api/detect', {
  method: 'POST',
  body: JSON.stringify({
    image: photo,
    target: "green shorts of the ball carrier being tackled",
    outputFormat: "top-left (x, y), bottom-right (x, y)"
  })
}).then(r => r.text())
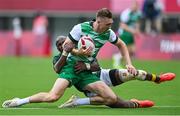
top-left (59, 60), bottom-right (100, 91)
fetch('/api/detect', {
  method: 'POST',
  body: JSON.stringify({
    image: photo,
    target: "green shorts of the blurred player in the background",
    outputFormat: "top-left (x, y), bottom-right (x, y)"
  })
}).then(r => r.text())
top-left (119, 31), bottom-right (134, 45)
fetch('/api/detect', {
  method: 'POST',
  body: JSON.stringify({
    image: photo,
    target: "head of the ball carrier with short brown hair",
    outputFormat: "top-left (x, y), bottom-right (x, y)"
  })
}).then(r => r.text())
top-left (96, 8), bottom-right (113, 33)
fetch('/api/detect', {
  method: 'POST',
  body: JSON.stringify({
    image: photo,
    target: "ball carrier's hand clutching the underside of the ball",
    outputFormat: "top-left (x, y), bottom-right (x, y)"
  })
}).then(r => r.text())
top-left (78, 46), bottom-right (93, 56)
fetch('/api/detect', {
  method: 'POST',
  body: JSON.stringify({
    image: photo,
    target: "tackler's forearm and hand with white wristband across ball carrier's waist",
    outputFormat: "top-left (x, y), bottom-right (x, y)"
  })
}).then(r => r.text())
top-left (74, 59), bottom-right (100, 73)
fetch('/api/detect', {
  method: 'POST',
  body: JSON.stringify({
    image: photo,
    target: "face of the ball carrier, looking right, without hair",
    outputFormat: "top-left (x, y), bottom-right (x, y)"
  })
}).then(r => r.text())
top-left (97, 18), bottom-right (113, 33)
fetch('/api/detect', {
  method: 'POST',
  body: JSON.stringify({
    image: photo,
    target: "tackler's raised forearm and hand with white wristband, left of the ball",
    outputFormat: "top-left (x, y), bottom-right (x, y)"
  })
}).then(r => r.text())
top-left (53, 38), bottom-right (74, 73)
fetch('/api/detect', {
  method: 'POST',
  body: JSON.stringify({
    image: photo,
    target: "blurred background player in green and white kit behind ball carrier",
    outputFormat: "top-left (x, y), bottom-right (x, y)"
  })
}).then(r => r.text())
top-left (113, 0), bottom-right (141, 68)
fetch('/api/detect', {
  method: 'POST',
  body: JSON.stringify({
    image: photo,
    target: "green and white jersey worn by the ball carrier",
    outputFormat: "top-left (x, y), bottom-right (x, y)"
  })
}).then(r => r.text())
top-left (68, 21), bottom-right (118, 62)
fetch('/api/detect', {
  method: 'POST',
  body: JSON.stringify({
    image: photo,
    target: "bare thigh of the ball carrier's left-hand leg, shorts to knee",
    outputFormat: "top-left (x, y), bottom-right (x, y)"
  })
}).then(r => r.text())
top-left (50, 78), bottom-right (69, 95)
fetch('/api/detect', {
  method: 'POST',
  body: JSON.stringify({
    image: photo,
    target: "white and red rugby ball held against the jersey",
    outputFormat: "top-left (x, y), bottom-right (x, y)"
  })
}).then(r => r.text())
top-left (78, 36), bottom-right (95, 55)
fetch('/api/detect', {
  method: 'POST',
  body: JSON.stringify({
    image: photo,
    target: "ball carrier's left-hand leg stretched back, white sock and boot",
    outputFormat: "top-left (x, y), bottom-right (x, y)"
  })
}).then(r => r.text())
top-left (2, 78), bottom-right (69, 107)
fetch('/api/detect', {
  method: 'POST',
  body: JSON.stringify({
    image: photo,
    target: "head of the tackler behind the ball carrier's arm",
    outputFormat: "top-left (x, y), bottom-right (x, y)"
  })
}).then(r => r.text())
top-left (56, 36), bottom-right (66, 52)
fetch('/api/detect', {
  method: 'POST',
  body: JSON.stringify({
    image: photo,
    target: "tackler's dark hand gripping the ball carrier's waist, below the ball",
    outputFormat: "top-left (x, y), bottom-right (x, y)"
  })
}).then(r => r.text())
top-left (74, 61), bottom-right (87, 74)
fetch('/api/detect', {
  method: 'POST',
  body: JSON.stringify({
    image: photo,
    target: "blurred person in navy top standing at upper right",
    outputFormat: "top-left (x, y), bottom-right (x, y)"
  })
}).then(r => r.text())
top-left (142, 0), bottom-right (164, 34)
